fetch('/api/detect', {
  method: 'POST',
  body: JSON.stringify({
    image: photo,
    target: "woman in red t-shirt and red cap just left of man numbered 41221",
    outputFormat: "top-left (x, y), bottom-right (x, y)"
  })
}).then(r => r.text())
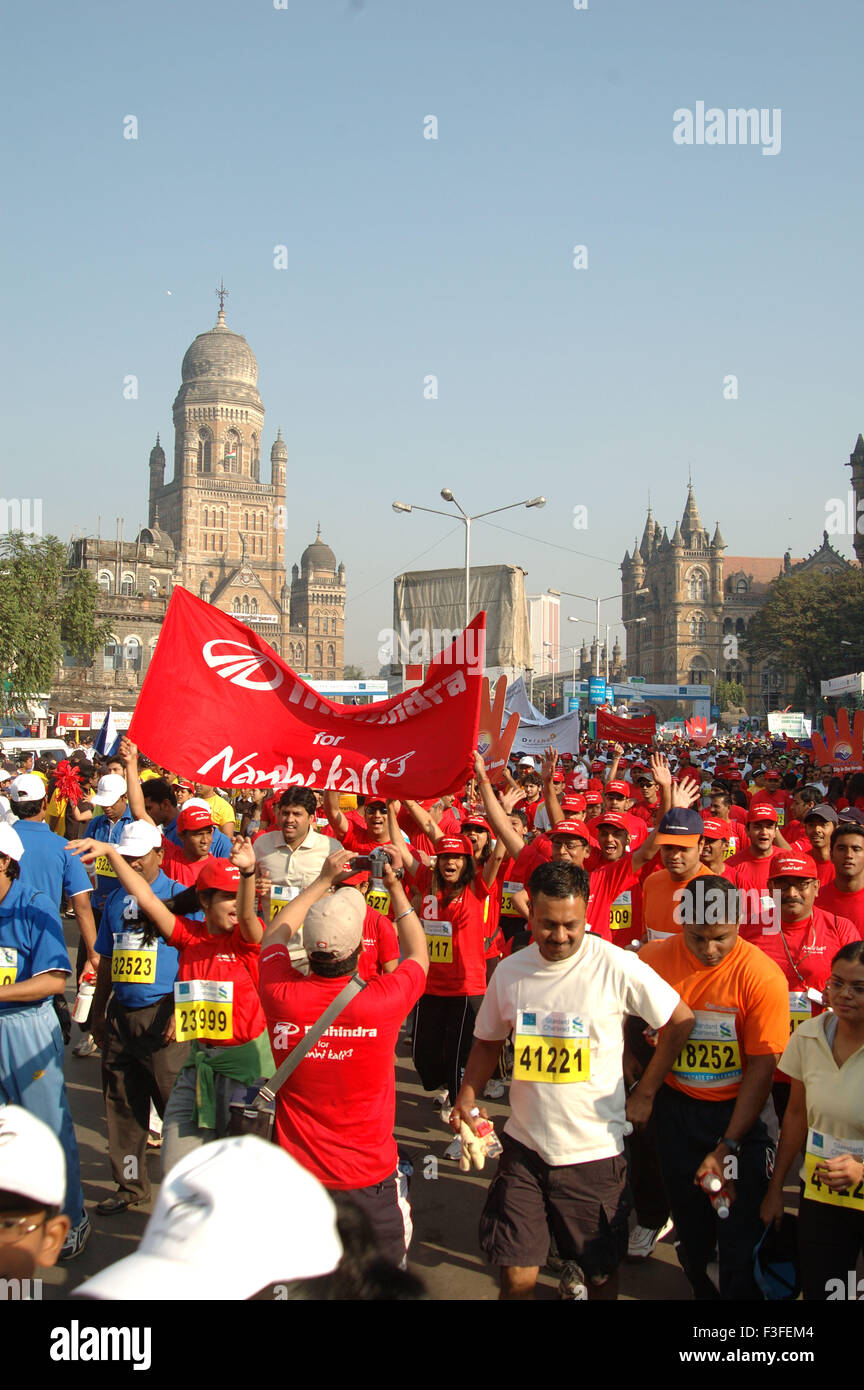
top-left (413, 835), bottom-right (500, 1102)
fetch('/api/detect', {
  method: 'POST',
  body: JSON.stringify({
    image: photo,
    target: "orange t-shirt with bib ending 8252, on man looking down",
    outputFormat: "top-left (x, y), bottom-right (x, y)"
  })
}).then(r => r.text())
top-left (639, 934), bottom-right (789, 1101)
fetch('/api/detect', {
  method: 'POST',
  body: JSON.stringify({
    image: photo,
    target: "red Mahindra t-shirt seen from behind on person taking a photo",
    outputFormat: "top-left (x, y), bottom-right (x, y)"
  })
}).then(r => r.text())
top-left (261, 945), bottom-right (425, 1191)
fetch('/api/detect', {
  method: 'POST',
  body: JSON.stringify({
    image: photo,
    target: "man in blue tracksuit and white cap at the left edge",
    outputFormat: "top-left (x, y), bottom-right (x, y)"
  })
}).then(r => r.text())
top-left (0, 824), bottom-right (90, 1259)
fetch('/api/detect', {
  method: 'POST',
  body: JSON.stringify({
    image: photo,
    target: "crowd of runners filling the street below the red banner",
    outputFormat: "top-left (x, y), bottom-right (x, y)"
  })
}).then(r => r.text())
top-left (0, 738), bottom-right (864, 1301)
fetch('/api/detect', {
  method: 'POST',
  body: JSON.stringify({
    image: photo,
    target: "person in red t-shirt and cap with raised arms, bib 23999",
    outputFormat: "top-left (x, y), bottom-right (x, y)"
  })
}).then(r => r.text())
top-left (75, 835), bottom-right (275, 1173)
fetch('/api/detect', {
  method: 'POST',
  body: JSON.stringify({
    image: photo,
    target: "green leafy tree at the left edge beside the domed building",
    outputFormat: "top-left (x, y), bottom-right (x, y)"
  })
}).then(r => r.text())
top-left (0, 531), bottom-right (107, 714)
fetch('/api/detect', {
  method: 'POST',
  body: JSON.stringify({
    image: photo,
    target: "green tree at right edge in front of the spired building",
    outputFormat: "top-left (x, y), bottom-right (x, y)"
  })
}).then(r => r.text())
top-left (740, 566), bottom-right (864, 712)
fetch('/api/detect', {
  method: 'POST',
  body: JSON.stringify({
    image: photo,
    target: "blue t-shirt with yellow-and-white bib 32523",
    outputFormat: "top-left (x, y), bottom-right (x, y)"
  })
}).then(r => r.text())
top-left (96, 869), bottom-right (198, 1009)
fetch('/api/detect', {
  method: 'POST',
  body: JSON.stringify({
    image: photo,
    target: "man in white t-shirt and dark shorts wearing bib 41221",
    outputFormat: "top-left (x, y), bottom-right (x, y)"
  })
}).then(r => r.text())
top-left (450, 860), bottom-right (693, 1300)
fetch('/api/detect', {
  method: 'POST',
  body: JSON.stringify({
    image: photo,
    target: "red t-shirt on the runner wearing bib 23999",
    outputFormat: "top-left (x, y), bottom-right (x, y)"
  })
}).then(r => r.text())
top-left (168, 917), bottom-right (267, 1047)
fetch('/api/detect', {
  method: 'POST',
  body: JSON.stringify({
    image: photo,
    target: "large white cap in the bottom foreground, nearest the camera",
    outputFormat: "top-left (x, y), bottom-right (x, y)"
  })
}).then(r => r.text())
top-left (75, 1134), bottom-right (342, 1301)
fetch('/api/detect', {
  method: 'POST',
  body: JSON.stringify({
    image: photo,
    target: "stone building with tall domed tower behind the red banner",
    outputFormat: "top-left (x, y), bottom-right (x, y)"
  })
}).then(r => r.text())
top-left (51, 291), bottom-right (346, 712)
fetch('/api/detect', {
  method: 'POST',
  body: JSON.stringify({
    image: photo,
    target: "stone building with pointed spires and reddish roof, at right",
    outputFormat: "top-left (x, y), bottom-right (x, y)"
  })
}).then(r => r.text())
top-left (621, 486), bottom-right (864, 716)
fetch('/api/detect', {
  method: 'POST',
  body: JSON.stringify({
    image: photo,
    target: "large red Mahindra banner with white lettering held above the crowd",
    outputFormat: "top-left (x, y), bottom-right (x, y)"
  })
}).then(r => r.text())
top-left (129, 588), bottom-right (486, 798)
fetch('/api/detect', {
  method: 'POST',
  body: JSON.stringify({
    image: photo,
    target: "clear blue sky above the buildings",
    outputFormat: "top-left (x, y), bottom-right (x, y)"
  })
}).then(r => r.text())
top-left (0, 0), bottom-right (864, 673)
